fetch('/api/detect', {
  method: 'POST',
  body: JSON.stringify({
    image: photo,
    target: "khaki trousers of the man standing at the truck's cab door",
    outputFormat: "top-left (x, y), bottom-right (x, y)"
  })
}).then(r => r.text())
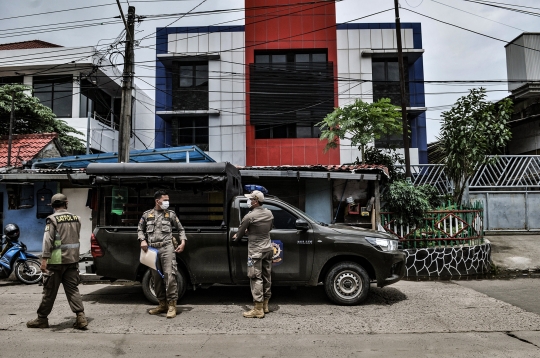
top-left (248, 251), bottom-right (273, 302)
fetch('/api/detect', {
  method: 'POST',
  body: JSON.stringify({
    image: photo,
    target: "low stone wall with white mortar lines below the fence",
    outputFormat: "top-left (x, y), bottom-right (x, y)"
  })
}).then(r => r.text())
top-left (403, 240), bottom-right (491, 277)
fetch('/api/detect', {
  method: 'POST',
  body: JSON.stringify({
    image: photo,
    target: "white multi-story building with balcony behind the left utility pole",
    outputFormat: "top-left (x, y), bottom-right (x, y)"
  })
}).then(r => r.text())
top-left (0, 40), bottom-right (154, 153)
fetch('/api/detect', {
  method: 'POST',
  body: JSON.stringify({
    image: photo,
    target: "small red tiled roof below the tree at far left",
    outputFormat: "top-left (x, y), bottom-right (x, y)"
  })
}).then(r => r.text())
top-left (0, 133), bottom-right (58, 167)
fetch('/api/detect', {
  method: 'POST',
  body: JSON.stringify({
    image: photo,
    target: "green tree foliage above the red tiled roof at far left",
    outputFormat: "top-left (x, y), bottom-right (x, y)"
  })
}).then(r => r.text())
top-left (0, 84), bottom-right (85, 153)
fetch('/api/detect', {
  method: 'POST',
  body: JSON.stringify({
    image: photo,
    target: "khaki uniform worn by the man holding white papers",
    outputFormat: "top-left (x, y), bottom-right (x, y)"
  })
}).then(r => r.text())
top-left (137, 209), bottom-right (187, 301)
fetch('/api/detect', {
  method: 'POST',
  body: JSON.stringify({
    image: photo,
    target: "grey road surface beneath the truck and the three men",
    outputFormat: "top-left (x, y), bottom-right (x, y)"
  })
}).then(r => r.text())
top-left (0, 280), bottom-right (540, 358)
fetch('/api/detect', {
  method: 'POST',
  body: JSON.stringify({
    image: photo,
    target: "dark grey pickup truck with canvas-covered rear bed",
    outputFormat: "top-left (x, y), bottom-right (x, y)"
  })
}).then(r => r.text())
top-left (87, 163), bottom-right (405, 305)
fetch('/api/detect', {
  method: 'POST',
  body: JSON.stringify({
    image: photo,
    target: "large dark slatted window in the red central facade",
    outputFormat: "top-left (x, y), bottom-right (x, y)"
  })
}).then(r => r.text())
top-left (249, 49), bottom-right (334, 139)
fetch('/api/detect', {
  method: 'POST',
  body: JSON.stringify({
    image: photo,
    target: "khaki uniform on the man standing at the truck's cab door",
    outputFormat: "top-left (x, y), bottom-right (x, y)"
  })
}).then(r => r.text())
top-left (238, 206), bottom-right (274, 302)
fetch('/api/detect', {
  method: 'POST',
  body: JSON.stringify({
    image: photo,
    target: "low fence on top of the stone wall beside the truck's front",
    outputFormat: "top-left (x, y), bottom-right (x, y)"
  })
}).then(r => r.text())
top-left (381, 202), bottom-right (484, 249)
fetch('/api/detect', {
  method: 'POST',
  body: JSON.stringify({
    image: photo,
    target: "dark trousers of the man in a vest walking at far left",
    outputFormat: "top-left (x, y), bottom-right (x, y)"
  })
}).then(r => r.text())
top-left (37, 263), bottom-right (84, 318)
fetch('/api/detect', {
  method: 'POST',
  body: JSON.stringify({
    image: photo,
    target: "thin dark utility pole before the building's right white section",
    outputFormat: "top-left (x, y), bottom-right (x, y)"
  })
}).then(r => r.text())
top-left (394, 0), bottom-right (411, 180)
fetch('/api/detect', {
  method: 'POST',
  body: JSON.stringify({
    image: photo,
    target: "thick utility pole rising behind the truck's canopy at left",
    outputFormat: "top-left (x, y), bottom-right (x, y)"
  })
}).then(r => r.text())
top-left (116, 0), bottom-right (135, 163)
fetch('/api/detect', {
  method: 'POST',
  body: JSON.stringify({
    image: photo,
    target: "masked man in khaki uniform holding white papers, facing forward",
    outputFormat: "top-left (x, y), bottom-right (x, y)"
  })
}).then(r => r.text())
top-left (137, 190), bottom-right (187, 318)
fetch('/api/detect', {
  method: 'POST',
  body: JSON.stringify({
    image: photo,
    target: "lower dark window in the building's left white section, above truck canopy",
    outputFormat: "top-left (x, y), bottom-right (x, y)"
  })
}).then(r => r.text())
top-left (172, 117), bottom-right (209, 150)
